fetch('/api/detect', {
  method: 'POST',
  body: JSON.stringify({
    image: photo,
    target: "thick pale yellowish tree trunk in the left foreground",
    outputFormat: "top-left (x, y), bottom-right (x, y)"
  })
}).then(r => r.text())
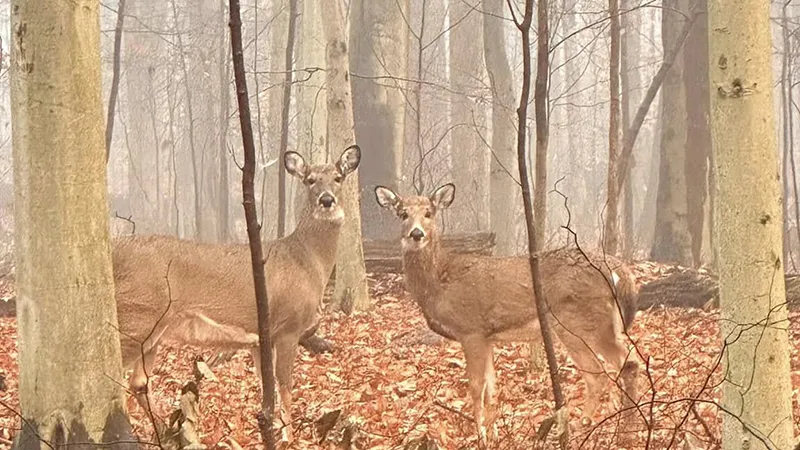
top-left (11, 0), bottom-right (136, 449)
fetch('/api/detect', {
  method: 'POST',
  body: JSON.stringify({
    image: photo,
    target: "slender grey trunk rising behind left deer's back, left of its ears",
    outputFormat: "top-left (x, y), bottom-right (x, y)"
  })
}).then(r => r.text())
top-left (278, 0), bottom-right (298, 238)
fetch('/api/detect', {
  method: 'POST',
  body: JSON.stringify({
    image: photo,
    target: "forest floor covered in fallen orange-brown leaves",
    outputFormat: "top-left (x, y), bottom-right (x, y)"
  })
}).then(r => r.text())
top-left (0, 264), bottom-right (800, 449)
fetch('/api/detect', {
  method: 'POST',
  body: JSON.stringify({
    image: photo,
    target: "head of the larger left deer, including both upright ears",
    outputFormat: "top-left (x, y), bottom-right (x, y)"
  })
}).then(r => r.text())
top-left (283, 145), bottom-right (361, 223)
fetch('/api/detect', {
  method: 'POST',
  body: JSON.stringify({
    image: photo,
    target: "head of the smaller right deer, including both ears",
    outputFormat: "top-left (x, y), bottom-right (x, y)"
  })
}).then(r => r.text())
top-left (375, 183), bottom-right (456, 251)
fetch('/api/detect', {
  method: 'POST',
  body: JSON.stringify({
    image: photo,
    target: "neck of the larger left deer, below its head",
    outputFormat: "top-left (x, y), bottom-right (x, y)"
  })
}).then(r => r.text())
top-left (292, 207), bottom-right (342, 275)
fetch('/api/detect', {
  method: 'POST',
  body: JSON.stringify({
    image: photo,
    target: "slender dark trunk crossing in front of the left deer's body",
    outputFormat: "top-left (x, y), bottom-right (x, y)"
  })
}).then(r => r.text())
top-left (230, 0), bottom-right (275, 450)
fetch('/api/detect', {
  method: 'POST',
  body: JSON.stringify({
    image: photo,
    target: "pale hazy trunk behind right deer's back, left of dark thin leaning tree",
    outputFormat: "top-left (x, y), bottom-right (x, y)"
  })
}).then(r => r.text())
top-left (482, 0), bottom-right (520, 256)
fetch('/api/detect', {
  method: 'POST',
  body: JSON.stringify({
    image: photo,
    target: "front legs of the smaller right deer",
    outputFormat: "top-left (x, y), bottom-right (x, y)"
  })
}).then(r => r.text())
top-left (462, 337), bottom-right (494, 442)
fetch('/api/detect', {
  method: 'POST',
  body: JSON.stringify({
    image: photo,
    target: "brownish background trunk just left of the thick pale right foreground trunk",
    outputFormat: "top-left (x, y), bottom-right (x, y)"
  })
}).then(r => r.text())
top-left (681, 0), bottom-right (711, 267)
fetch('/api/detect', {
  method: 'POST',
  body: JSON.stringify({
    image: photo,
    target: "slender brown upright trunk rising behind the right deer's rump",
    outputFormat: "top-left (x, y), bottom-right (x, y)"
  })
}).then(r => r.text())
top-left (603, 0), bottom-right (630, 255)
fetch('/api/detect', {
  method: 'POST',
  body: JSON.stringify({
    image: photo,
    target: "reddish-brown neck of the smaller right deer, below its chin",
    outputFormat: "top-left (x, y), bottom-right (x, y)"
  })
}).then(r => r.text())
top-left (403, 239), bottom-right (444, 303)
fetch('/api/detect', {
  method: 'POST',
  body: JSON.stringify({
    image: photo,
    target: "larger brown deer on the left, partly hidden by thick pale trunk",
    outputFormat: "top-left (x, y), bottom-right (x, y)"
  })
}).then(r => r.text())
top-left (113, 145), bottom-right (361, 443)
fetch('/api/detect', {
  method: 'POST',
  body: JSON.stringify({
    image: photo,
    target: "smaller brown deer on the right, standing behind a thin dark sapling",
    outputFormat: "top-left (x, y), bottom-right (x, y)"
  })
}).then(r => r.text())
top-left (375, 184), bottom-right (638, 439)
